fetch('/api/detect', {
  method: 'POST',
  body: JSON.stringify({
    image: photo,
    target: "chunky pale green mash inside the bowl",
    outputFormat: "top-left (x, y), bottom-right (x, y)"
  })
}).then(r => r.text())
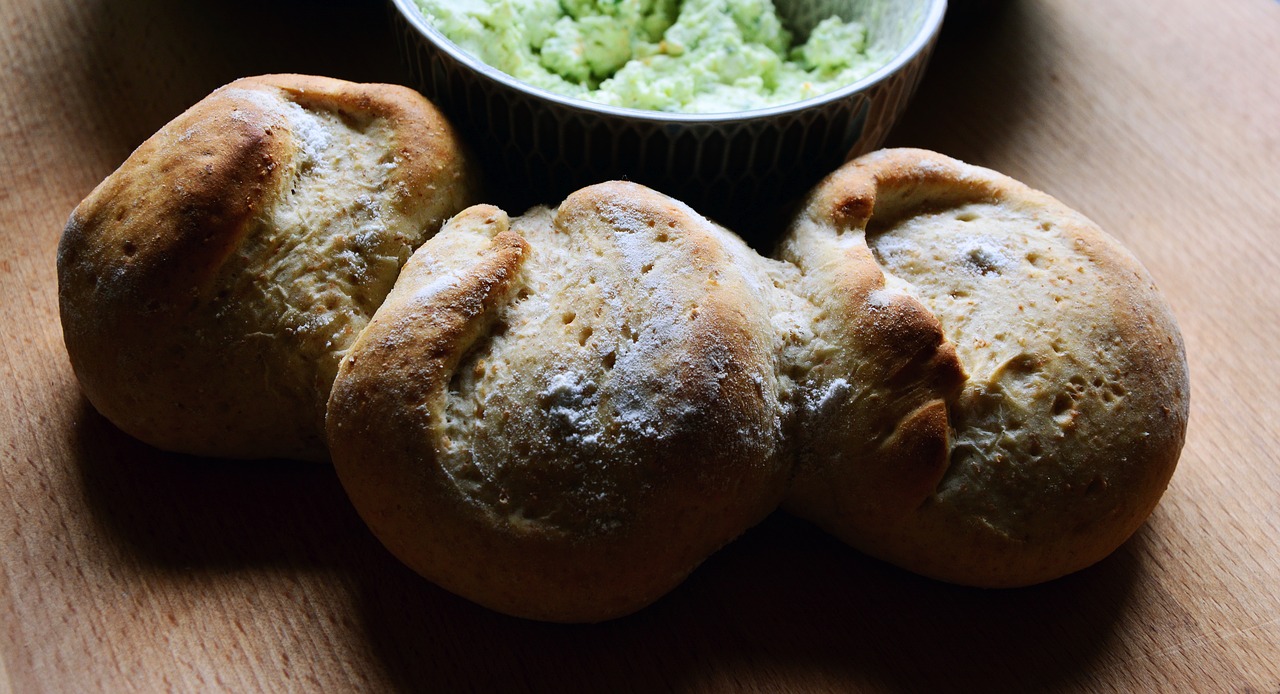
top-left (417, 0), bottom-right (887, 113)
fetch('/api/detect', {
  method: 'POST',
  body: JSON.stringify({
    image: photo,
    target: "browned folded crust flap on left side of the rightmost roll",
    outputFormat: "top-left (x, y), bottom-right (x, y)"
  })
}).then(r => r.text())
top-left (780, 153), bottom-right (965, 525)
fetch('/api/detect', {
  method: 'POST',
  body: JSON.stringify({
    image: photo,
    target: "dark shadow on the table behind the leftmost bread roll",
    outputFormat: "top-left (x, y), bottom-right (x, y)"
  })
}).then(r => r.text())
top-left (67, 0), bottom-right (408, 169)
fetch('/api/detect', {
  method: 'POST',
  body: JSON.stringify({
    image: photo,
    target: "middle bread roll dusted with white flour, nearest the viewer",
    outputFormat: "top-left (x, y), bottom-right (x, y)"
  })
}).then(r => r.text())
top-left (329, 182), bottom-right (787, 622)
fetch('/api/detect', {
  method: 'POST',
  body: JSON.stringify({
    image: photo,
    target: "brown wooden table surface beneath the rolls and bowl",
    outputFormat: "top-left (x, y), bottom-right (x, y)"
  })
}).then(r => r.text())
top-left (0, 0), bottom-right (1280, 693)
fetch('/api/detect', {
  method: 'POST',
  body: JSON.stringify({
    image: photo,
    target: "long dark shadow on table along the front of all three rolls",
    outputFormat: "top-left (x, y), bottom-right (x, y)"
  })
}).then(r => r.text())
top-left (76, 401), bottom-right (1143, 691)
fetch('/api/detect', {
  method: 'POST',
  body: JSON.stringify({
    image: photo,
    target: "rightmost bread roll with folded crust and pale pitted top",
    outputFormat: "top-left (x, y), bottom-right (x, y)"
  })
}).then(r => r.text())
top-left (781, 150), bottom-right (1189, 586)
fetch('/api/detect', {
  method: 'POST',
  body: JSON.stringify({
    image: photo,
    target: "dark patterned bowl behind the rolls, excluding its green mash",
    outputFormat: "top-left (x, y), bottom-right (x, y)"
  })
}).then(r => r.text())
top-left (390, 0), bottom-right (946, 242)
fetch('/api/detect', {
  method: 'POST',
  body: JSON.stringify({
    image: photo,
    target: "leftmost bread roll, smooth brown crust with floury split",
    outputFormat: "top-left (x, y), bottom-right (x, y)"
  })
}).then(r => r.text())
top-left (58, 74), bottom-right (476, 460)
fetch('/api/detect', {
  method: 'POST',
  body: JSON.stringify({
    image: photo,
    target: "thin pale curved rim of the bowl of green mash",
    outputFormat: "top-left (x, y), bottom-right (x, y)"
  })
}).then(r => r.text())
top-left (390, 0), bottom-right (947, 124)
